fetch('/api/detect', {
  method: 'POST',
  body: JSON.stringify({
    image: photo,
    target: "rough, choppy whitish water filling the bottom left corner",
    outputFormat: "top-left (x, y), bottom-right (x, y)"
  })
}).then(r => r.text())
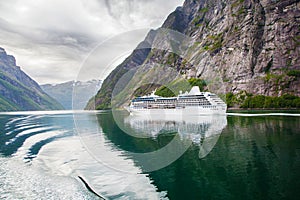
top-left (0, 157), bottom-right (96, 200)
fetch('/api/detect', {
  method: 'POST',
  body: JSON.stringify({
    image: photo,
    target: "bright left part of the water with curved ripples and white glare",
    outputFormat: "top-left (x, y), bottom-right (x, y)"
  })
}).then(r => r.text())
top-left (0, 112), bottom-right (166, 199)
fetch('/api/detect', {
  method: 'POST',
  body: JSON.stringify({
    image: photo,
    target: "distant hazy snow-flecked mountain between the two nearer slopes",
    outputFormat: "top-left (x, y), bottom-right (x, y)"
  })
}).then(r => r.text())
top-left (41, 80), bottom-right (101, 110)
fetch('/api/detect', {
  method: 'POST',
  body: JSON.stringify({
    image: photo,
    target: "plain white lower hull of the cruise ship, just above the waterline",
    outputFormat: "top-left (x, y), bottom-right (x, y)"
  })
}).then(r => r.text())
top-left (126, 106), bottom-right (226, 116)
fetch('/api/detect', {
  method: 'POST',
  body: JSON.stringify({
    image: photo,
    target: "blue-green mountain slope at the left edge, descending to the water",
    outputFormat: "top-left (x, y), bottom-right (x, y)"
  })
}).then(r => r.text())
top-left (0, 48), bottom-right (63, 111)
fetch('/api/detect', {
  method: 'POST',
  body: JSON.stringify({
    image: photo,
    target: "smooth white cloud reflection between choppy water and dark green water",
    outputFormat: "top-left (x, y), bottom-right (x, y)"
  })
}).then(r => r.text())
top-left (33, 135), bottom-right (165, 199)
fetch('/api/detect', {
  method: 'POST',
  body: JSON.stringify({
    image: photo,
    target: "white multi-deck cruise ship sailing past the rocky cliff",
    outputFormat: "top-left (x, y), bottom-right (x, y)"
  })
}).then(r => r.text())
top-left (126, 86), bottom-right (227, 115)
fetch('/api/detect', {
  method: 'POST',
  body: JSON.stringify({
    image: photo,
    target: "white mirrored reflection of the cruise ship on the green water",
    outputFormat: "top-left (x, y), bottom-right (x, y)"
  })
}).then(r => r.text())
top-left (124, 115), bottom-right (227, 158)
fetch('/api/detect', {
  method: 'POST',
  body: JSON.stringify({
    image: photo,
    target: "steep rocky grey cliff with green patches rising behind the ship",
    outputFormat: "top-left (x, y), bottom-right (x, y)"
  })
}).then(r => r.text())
top-left (87, 0), bottom-right (300, 109)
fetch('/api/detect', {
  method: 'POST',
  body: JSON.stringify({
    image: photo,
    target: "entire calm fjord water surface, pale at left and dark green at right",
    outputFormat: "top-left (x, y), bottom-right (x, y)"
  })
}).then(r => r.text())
top-left (0, 112), bottom-right (300, 199)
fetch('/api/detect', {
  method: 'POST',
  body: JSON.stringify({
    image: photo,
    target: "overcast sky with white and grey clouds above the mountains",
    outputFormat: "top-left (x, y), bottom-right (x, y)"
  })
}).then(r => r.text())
top-left (0, 0), bottom-right (184, 84)
